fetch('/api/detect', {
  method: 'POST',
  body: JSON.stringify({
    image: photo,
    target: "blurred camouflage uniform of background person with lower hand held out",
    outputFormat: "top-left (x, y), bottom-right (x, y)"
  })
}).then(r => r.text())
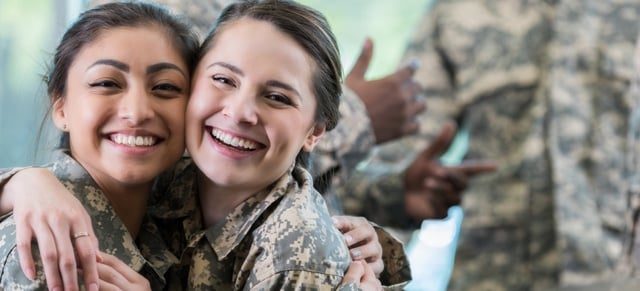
top-left (343, 0), bottom-right (558, 290)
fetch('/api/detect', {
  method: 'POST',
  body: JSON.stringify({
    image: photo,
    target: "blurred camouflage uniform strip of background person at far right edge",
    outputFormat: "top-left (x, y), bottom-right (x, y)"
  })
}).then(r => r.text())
top-left (543, 0), bottom-right (640, 285)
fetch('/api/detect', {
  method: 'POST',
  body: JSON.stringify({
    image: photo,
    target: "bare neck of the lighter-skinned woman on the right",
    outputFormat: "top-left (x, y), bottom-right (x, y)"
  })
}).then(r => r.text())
top-left (198, 172), bottom-right (257, 228)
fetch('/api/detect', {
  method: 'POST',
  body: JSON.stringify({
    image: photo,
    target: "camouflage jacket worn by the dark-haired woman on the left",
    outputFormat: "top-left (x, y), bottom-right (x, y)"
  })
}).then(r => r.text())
top-left (0, 151), bottom-right (178, 290)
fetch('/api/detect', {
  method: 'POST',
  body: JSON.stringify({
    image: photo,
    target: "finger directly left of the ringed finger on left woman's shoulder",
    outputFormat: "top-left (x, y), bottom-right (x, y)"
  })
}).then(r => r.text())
top-left (50, 220), bottom-right (78, 290)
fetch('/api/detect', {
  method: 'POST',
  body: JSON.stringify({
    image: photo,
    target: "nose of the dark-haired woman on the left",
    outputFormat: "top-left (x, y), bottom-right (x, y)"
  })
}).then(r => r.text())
top-left (119, 86), bottom-right (155, 126)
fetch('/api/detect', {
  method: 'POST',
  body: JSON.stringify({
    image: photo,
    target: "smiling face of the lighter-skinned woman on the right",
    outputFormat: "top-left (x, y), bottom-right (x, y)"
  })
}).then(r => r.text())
top-left (187, 18), bottom-right (324, 193)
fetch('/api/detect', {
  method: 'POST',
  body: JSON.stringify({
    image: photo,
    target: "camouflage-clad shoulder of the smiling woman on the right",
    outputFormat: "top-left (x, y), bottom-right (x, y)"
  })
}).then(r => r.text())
top-left (252, 171), bottom-right (350, 276)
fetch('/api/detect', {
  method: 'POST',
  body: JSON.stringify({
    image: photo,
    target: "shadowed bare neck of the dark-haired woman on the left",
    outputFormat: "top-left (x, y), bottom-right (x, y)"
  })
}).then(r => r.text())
top-left (98, 183), bottom-right (151, 238)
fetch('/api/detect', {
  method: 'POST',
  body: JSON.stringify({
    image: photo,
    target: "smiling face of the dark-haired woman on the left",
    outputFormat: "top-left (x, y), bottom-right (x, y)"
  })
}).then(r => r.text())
top-left (54, 26), bottom-right (189, 187)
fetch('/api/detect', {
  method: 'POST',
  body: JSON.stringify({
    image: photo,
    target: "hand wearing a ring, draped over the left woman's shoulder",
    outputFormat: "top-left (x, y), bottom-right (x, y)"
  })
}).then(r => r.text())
top-left (0, 168), bottom-right (99, 290)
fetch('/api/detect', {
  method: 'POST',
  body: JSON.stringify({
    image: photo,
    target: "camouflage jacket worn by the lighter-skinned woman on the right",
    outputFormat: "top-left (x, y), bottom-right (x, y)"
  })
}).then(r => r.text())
top-left (152, 160), bottom-right (350, 290)
